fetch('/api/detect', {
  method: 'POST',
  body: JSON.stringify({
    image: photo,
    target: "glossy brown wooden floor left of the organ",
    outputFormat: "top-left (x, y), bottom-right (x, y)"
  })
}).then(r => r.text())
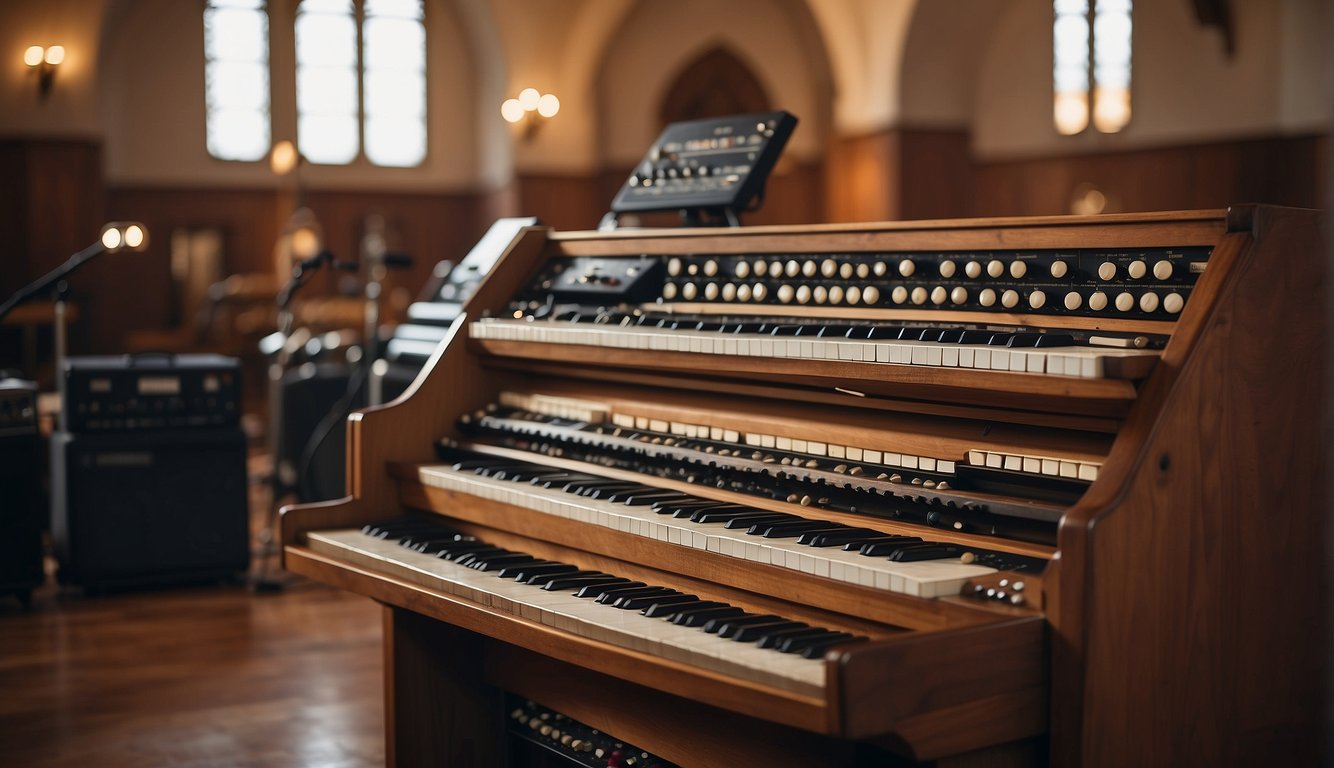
top-left (0, 469), bottom-right (384, 768)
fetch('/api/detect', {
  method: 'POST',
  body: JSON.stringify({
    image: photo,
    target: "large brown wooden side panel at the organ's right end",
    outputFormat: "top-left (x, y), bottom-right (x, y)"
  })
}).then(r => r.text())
top-left (1053, 211), bottom-right (1327, 765)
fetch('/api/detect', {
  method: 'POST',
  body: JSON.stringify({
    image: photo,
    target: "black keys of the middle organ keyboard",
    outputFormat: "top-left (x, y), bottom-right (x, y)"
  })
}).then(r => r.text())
top-left (442, 449), bottom-right (1041, 571)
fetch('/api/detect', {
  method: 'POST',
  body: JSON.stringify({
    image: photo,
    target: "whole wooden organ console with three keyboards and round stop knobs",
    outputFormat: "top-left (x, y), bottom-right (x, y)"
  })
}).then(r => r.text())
top-left (281, 207), bottom-right (1327, 767)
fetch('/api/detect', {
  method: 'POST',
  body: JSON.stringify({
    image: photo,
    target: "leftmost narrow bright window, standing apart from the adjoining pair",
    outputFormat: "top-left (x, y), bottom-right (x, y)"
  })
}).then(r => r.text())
top-left (204, 0), bottom-right (269, 160)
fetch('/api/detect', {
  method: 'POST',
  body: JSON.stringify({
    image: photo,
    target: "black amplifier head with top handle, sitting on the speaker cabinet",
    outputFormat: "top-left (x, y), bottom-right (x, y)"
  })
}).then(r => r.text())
top-left (64, 352), bottom-right (241, 433)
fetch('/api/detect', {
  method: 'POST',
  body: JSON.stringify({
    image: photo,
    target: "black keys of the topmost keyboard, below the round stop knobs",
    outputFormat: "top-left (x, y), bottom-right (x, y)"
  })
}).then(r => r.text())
top-left (554, 309), bottom-right (1078, 348)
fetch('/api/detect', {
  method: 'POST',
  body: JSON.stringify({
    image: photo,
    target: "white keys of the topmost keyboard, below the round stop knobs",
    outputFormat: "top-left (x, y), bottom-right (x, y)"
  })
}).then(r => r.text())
top-left (471, 319), bottom-right (1158, 379)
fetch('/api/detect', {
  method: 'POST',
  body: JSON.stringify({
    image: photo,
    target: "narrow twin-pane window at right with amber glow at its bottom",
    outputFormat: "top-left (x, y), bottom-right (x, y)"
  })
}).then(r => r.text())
top-left (1053, 0), bottom-right (1131, 136)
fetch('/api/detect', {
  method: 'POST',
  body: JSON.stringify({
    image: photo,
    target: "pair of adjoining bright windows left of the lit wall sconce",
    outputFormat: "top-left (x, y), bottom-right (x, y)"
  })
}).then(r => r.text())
top-left (296, 0), bottom-right (426, 167)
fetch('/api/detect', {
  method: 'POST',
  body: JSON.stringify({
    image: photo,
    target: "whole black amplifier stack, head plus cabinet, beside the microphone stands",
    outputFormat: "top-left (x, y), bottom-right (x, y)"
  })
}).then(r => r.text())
top-left (51, 355), bottom-right (249, 591)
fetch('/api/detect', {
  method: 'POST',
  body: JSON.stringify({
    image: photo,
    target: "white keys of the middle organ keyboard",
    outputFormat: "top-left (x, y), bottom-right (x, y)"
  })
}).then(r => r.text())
top-left (418, 465), bottom-right (995, 597)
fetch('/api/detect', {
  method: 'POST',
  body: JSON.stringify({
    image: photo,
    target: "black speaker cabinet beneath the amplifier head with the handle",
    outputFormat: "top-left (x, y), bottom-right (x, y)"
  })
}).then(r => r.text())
top-left (51, 427), bottom-right (249, 591)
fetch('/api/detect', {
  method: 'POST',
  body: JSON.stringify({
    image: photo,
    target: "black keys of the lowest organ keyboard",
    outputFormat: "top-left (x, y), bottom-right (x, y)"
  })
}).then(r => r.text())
top-left (362, 517), bottom-right (864, 659)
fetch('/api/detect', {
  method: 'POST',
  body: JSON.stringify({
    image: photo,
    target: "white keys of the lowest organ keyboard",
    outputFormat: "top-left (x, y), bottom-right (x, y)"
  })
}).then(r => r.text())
top-left (308, 529), bottom-right (824, 695)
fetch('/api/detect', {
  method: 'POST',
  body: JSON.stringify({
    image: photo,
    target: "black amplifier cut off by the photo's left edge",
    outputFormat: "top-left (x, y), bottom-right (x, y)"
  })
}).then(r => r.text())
top-left (0, 379), bottom-right (45, 604)
